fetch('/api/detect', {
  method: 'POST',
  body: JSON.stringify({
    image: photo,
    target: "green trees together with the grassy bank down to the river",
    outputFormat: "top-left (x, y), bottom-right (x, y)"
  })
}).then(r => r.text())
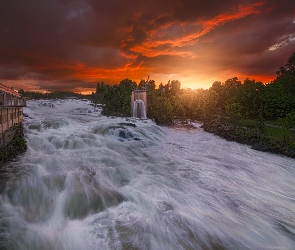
top-left (93, 53), bottom-right (295, 158)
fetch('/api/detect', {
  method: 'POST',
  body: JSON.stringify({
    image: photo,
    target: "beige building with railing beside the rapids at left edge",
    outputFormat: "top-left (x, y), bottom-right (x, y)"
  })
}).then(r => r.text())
top-left (0, 83), bottom-right (26, 147)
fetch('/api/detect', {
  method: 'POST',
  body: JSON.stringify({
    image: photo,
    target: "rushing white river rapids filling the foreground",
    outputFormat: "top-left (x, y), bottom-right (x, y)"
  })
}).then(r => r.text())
top-left (0, 100), bottom-right (295, 250)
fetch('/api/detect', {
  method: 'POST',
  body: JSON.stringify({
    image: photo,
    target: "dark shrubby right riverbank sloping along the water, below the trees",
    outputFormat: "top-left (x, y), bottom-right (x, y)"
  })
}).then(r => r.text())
top-left (201, 119), bottom-right (295, 159)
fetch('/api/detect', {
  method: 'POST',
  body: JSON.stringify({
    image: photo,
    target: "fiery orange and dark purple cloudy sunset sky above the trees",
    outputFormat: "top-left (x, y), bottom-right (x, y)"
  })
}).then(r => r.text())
top-left (0, 0), bottom-right (295, 93)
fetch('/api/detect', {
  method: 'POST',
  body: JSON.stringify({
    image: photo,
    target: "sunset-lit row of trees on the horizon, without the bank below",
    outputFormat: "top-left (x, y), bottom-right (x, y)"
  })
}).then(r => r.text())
top-left (93, 53), bottom-right (295, 127)
